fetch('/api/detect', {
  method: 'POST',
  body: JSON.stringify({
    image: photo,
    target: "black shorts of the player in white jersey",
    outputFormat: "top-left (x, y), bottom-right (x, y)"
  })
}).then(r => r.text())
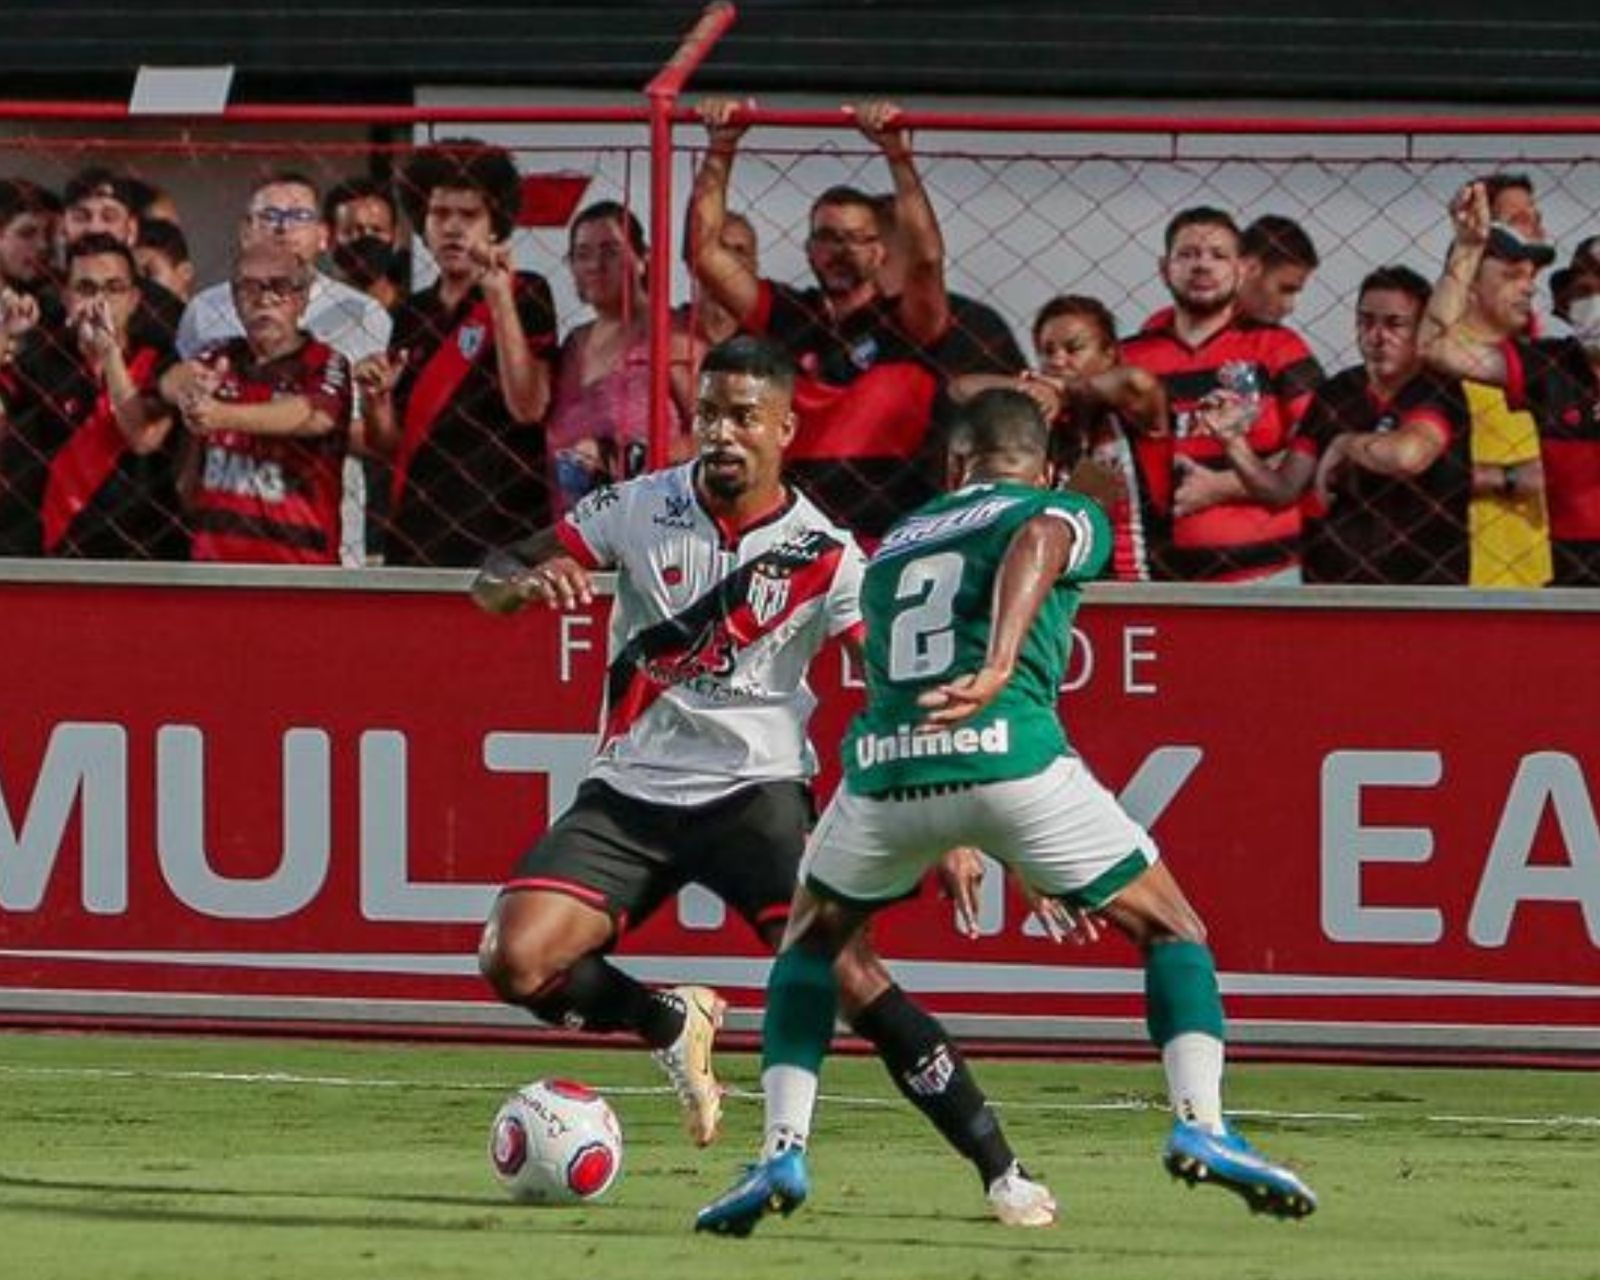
top-left (506, 781), bottom-right (816, 936)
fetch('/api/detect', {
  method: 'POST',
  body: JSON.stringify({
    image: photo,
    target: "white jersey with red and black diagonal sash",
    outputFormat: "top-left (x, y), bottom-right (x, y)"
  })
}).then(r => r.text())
top-left (557, 462), bottom-right (862, 805)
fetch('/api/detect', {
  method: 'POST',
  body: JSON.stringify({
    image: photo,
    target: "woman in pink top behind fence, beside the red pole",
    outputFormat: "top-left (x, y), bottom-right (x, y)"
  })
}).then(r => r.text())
top-left (544, 200), bottom-right (694, 515)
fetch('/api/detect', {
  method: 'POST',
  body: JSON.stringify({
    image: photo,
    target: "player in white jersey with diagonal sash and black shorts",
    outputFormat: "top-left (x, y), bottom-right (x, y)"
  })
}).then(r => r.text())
top-left (474, 338), bottom-right (1056, 1226)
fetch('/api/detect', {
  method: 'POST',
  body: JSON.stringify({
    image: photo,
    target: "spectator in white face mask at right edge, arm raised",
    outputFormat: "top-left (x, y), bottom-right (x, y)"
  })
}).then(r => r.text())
top-left (1422, 182), bottom-right (1600, 587)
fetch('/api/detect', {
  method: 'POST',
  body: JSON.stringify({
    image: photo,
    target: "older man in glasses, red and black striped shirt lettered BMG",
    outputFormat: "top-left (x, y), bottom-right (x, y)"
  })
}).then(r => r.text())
top-left (162, 242), bottom-right (350, 565)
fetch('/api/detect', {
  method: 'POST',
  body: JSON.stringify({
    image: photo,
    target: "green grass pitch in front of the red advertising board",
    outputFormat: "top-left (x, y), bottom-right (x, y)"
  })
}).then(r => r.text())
top-left (0, 1034), bottom-right (1600, 1280)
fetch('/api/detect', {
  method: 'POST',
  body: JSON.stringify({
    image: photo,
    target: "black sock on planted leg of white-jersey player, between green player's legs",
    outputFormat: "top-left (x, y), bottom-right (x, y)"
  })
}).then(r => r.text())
top-left (853, 987), bottom-right (1016, 1187)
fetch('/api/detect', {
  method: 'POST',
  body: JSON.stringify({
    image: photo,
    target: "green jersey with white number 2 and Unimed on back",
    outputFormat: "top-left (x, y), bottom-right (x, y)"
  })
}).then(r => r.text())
top-left (845, 483), bottom-right (1110, 795)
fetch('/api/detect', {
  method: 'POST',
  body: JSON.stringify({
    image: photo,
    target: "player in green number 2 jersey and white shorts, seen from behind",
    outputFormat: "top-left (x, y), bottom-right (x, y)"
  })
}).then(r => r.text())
top-left (694, 389), bottom-right (1317, 1235)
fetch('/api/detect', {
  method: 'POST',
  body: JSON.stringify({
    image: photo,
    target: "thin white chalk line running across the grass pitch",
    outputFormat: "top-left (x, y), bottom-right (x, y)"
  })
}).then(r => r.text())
top-left (0, 1062), bottom-right (1600, 1130)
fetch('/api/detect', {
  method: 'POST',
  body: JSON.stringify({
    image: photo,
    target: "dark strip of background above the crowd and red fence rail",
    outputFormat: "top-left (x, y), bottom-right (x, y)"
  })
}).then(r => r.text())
top-left (0, 0), bottom-right (1600, 104)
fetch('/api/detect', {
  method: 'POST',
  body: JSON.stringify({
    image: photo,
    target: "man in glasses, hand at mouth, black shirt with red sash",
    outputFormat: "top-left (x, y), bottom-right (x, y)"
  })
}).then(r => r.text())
top-left (0, 232), bottom-right (187, 560)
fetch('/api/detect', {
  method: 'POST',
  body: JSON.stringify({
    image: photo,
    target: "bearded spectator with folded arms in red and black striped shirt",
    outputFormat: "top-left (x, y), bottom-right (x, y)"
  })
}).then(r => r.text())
top-left (1123, 206), bottom-right (1322, 582)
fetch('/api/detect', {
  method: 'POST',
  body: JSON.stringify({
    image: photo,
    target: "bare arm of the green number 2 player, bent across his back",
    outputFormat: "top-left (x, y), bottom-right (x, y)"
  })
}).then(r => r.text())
top-left (917, 515), bottom-right (1074, 725)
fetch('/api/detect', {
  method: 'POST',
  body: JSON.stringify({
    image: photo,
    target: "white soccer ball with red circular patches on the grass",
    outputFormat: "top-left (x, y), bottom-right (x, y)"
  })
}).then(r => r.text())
top-left (490, 1080), bottom-right (622, 1205)
